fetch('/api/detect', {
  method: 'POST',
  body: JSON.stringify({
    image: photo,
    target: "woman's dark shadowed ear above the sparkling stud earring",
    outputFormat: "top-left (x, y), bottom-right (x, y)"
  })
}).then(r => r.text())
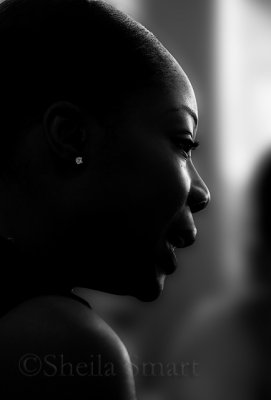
top-left (43, 101), bottom-right (87, 162)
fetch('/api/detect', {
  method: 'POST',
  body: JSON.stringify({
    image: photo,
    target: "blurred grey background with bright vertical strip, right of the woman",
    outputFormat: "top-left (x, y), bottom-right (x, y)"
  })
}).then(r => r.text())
top-left (76, 0), bottom-right (271, 400)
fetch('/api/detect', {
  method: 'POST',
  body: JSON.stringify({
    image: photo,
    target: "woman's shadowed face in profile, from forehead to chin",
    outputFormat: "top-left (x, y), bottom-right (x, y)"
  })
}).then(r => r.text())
top-left (70, 65), bottom-right (209, 300)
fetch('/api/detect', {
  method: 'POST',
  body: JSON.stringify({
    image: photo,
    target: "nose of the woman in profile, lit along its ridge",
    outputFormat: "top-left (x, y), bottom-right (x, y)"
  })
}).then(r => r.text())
top-left (188, 164), bottom-right (211, 213)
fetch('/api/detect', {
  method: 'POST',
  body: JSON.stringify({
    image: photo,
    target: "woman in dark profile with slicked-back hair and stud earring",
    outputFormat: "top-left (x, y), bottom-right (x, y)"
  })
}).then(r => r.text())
top-left (0, 0), bottom-right (210, 399)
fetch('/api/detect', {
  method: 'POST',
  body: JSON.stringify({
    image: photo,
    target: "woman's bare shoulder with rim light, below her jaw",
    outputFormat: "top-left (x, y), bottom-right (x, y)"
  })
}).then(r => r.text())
top-left (0, 296), bottom-right (135, 400)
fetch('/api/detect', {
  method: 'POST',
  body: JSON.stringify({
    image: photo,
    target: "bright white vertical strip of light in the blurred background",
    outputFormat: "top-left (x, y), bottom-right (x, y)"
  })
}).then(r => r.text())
top-left (218, 0), bottom-right (271, 280)
